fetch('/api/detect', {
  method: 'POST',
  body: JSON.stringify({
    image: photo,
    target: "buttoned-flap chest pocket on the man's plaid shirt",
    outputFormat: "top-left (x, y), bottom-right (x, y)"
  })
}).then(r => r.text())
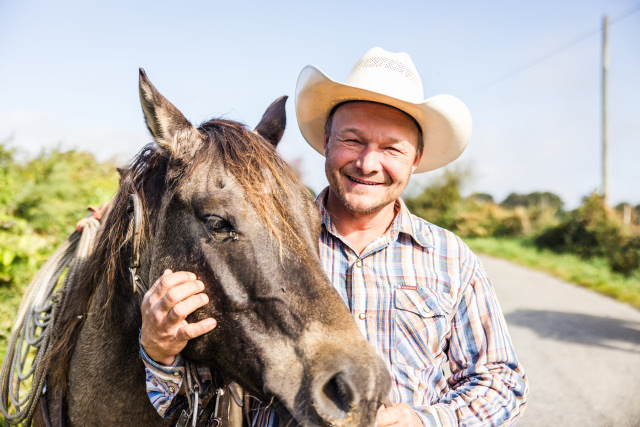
top-left (394, 287), bottom-right (453, 369)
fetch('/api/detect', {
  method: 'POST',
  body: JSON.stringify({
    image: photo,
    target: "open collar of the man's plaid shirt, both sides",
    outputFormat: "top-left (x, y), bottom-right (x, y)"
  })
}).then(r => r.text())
top-left (316, 187), bottom-right (434, 248)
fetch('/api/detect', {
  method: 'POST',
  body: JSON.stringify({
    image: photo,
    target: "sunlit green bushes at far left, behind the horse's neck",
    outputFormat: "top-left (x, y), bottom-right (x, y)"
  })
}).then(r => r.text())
top-left (0, 142), bottom-right (118, 362)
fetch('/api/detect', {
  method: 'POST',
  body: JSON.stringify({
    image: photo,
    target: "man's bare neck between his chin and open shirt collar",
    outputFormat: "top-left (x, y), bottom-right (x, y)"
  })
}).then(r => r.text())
top-left (326, 189), bottom-right (395, 254)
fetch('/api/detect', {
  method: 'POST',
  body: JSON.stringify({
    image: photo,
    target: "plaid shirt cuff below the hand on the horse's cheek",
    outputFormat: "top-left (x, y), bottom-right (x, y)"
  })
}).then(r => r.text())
top-left (140, 344), bottom-right (184, 418)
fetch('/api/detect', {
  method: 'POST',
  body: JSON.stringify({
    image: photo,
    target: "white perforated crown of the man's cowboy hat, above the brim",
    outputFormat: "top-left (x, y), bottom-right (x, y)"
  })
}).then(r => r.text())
top-left (345, 47), bottom-right (424, 103)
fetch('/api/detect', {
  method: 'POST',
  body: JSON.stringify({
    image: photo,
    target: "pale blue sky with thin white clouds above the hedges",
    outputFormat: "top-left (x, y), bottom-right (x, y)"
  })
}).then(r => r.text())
top-left (0, 0), bottom-right (640, 207)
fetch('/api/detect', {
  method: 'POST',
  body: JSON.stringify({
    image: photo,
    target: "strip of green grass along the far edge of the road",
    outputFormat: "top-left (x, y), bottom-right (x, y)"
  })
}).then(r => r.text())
top-left (464, 237), bottom-right (640, 309)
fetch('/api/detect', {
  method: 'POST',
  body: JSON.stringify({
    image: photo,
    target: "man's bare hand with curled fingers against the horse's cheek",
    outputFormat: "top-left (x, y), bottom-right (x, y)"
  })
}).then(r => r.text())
top-left (140, 270), bottom-right (216, 365)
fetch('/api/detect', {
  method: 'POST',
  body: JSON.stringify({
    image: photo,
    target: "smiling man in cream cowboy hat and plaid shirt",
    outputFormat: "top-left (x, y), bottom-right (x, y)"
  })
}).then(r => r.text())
top-left (140, 48), bottom-right (528, 426)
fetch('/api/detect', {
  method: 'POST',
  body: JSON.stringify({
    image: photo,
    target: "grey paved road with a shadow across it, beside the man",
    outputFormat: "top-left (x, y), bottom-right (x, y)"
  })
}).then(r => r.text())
top-left (481, 256), bottom-right (640, 427)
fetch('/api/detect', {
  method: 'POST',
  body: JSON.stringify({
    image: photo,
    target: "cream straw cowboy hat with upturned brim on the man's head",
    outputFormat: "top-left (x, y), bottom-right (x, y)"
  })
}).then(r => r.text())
top-left (296, 47), bottom-right (471, 173)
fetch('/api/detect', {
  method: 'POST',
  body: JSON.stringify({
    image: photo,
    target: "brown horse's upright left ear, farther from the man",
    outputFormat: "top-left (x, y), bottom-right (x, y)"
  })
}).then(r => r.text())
top-left (139, 68), bottom-right (195, 152)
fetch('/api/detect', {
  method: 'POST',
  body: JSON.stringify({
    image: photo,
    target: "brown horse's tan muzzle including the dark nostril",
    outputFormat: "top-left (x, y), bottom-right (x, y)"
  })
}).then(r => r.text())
top-left (261, 323), bottom-right (390, 427)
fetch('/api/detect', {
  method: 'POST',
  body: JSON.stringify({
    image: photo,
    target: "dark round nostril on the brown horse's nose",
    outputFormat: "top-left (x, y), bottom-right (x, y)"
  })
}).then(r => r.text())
top-left (313, 372), bottom-right (358, 421)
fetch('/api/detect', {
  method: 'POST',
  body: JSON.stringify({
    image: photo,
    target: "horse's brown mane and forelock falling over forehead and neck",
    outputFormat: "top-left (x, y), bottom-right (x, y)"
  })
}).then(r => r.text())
top-left (49, 119), bottom-right (306, 393)
